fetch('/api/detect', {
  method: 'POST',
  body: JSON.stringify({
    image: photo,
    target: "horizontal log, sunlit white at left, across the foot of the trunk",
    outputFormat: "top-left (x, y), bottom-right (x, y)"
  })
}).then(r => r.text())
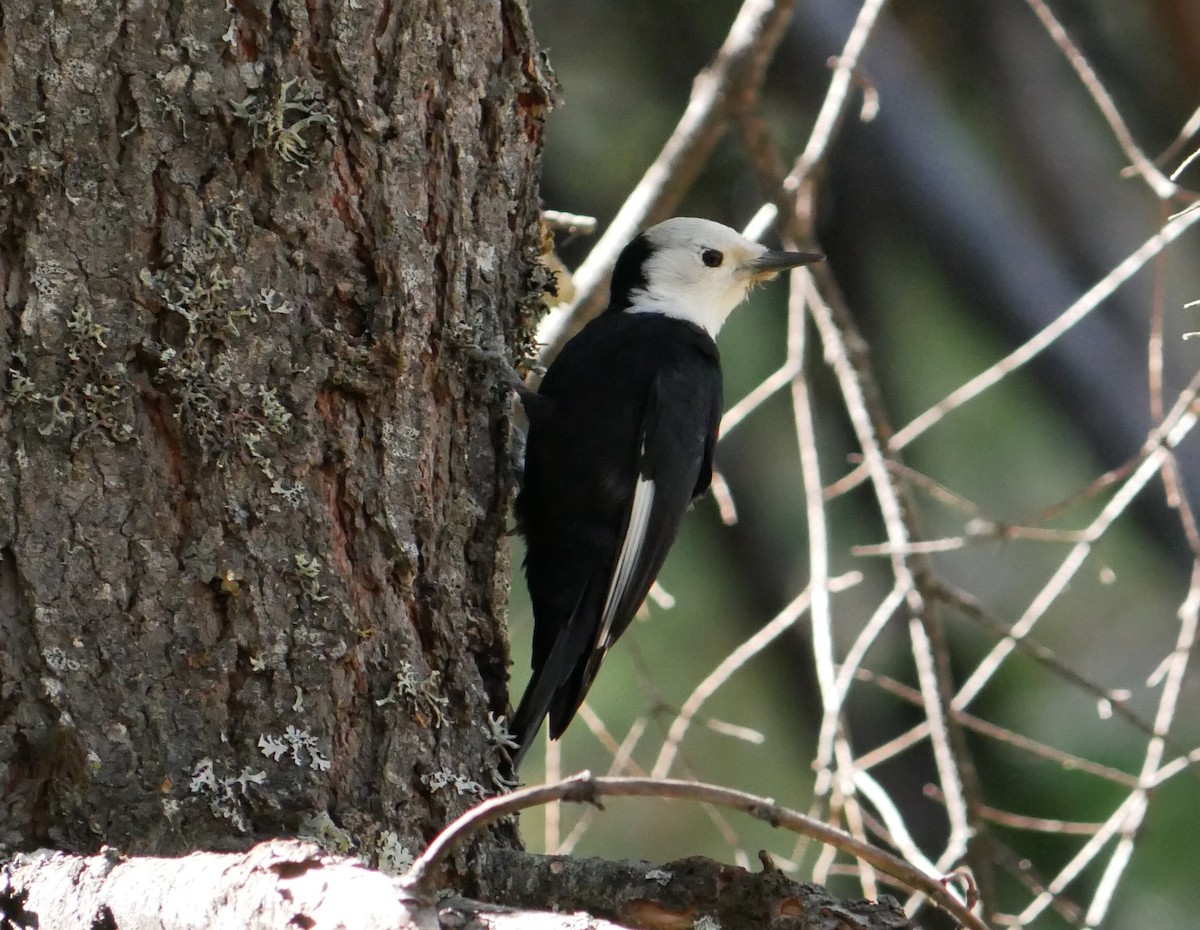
top-left (0, 840), bottom-right (911, 930)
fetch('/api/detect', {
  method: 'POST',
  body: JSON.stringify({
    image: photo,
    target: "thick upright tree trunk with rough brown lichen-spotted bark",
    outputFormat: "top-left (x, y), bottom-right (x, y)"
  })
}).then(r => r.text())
top-left (0, 0), bottom-right (551, 864)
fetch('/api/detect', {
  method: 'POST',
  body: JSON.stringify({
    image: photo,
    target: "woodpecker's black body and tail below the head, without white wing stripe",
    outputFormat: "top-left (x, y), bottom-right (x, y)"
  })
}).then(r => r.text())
top-left (512, 309), bottom-right (722, 751)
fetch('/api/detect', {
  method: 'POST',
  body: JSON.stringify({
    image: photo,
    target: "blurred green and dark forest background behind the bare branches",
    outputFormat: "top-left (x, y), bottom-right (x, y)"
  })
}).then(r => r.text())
top-left (511, 0), bottom-right (1200, 928)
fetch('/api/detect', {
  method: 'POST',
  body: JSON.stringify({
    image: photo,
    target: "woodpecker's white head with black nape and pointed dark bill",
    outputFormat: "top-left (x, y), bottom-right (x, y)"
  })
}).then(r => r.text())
top-left (612, 216), bottom-right (822, 338)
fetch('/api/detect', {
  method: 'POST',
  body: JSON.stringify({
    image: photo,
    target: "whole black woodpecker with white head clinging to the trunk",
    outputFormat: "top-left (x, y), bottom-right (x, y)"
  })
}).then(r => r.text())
top-left (510, 217), bottom-right (821, 766)
